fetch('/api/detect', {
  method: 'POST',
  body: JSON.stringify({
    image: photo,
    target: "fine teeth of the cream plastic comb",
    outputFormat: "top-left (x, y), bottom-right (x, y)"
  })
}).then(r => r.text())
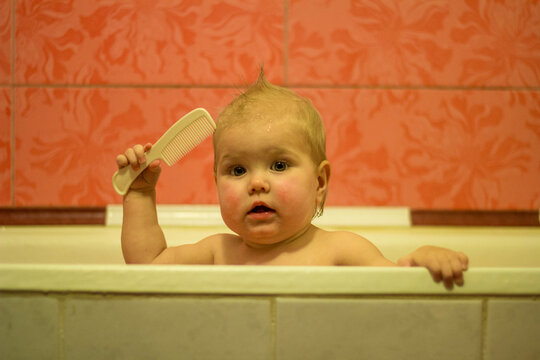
top-left (162, 116), bottom-right (214, 166)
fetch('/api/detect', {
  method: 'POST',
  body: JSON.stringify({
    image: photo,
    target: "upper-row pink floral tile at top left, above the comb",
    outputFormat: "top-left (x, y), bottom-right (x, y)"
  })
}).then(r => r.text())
top-left (15, 0), bottom-right (283, 85)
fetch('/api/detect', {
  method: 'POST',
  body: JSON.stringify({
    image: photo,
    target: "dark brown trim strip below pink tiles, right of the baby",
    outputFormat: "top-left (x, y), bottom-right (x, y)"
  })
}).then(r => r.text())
top-left (411, 209), bottom-right (540, 226)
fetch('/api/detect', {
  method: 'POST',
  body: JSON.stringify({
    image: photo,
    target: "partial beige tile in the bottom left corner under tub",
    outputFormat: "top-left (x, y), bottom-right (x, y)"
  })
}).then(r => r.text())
top-left (0, 294), bottom-right (58, 359)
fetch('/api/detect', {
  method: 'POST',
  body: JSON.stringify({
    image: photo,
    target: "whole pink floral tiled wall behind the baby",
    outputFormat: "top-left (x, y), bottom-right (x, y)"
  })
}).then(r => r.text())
top-left (0, 0), bottom-right (540, 209)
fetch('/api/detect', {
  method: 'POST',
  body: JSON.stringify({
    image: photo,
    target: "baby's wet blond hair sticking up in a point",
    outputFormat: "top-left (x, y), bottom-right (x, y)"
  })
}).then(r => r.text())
top-left (213, 69), bottom-right (327, 217)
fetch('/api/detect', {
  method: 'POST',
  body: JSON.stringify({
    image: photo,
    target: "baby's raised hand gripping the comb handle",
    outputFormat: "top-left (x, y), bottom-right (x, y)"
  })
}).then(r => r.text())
top-left (116, 143), bottom-right (161, 192)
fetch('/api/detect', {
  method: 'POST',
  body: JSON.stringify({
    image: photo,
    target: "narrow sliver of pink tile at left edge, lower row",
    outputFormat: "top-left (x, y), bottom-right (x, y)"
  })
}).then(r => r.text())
top-left (0, 88), bottom-right (11, 205)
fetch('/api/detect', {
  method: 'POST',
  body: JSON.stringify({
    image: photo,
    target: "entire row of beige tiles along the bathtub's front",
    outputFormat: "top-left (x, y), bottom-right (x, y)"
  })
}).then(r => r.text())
top-left (0, 294), bottom-right (540, 360)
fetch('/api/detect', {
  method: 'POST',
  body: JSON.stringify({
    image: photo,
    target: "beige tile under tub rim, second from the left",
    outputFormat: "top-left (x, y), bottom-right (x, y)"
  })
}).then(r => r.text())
top-left (65, 297), bottom-right (271, 360)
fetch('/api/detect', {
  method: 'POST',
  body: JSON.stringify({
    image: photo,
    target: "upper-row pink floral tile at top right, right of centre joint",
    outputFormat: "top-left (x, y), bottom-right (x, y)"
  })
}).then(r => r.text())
top-left (288, 0), bottom-right (540, 86)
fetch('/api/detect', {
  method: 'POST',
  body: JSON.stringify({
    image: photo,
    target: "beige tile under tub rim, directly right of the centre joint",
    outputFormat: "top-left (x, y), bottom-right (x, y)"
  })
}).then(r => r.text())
top-left (276, 299), bottom-right (482, 360)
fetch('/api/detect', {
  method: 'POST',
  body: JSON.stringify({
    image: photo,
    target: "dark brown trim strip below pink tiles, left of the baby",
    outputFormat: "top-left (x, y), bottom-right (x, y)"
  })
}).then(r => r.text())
top-left (0, 206), bottom-right (106, 225)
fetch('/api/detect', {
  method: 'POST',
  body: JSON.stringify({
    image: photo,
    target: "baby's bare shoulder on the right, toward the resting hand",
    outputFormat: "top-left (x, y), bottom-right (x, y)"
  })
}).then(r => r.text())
top-left (324, 231), bottom-right (395, 266)
